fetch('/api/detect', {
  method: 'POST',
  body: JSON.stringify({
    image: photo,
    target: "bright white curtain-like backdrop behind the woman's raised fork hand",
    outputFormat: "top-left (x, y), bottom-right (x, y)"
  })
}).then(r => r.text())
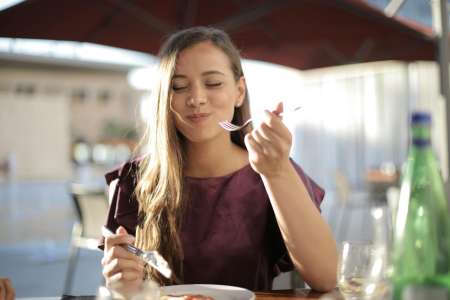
top-left (244, 61), bottom-right (446, 231)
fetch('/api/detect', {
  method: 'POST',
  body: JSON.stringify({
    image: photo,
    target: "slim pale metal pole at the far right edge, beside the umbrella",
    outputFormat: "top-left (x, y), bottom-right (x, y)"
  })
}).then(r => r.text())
top-left (431, 0), bottom-right (450, 202)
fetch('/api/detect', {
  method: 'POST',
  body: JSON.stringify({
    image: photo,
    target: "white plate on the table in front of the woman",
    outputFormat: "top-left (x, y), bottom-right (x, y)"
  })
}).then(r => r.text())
top-left (161, 284), bottom-right (255, 300)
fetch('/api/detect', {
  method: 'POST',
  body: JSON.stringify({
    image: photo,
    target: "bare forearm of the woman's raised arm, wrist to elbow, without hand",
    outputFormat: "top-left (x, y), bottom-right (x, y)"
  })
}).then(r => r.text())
top-left (261, 163), bottom-right (337, 291)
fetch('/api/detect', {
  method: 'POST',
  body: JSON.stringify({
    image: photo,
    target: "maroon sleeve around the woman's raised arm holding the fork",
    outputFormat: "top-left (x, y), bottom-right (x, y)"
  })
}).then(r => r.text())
top-left (267, 160), bottom-right (325, 276)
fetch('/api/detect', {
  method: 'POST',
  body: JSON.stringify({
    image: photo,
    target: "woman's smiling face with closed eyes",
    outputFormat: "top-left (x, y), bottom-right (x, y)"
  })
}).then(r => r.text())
top-left (170, 42), bottom-right (245, 142)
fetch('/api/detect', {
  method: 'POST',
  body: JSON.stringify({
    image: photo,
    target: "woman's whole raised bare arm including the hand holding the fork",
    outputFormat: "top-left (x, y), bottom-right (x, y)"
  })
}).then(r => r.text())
top-left (245, 103), bottom-right (337, 291)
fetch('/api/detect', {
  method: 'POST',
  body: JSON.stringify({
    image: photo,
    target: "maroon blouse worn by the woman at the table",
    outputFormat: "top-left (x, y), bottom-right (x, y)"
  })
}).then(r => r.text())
top-left (101, 161), bottom-right (324, 290)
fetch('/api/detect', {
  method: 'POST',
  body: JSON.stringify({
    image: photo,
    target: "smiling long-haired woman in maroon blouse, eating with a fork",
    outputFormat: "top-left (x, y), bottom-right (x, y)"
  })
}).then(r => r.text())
top-left (102, 27), bottom-right (336, 291)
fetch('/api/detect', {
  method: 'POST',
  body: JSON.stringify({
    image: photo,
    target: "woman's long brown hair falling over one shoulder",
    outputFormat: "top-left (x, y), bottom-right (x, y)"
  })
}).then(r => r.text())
top-left (135, 27), bottom-right (251, 284)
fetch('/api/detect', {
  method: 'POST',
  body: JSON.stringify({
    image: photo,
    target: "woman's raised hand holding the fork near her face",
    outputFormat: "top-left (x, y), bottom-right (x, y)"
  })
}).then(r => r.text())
top-left (245, 102), bottom-right (292, 177)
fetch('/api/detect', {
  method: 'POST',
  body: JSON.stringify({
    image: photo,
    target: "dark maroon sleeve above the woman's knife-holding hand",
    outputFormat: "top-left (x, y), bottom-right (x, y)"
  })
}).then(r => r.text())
top-left (99, 161), bottom-right (139, 249)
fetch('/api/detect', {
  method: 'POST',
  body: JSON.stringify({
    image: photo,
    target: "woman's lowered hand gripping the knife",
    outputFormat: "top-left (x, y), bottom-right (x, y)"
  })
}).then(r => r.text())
top-left (102, 226), bottom-right (144, 292)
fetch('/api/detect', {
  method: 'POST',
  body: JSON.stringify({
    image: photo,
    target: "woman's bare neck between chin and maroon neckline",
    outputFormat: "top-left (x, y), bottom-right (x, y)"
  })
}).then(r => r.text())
top-left (185, 136), bottom-right (248, 177)
